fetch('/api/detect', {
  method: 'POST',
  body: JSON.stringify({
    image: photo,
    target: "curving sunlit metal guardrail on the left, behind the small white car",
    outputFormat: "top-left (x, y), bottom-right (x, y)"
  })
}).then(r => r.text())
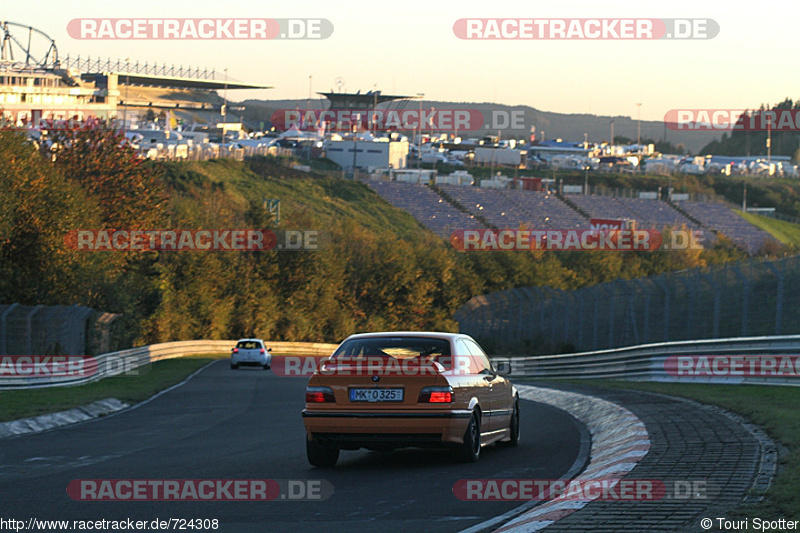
top-left (0, 340), bottom-right (337, 390)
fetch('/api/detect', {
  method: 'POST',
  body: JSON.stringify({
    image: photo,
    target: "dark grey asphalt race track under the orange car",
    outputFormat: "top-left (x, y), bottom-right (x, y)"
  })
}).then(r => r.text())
top-left (0, 361), bottom-right (582, 533)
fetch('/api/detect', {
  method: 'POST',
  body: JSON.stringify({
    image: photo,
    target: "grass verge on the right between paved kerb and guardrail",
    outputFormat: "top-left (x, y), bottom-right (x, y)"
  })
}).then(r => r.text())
top-left (538, 380), bottom-right (800, 524)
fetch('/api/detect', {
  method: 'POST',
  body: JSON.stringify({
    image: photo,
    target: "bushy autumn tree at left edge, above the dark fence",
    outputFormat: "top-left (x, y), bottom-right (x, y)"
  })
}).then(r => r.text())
top-left (0, 131), bottom-right (115, 306)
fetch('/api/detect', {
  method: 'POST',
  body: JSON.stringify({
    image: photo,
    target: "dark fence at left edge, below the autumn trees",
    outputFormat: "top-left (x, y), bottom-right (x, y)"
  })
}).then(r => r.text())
top-left (0, 304), bottom-right (120, 355)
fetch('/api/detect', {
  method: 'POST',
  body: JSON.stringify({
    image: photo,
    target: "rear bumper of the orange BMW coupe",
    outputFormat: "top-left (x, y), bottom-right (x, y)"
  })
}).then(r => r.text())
top-left (303, 409), bottom-right (472, 447)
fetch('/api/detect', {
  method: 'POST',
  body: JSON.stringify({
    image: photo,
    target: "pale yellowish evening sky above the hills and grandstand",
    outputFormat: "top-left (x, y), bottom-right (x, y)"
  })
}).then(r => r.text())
top-left (0, 0), bottom-right (800, 120)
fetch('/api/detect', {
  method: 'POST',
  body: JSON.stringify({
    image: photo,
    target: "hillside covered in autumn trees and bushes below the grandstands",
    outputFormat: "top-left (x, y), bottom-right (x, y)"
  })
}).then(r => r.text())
top-left (0, 130), bottom-right (776, 347)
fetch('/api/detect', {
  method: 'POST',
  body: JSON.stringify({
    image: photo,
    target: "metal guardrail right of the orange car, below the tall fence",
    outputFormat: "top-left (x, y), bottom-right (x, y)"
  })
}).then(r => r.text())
top-left (492, 335), bottom-right (800, 386)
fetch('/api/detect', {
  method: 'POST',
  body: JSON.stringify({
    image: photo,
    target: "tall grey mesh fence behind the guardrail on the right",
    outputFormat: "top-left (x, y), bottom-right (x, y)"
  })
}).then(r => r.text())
top-left (454, 257), bottom-right (800, 355)
